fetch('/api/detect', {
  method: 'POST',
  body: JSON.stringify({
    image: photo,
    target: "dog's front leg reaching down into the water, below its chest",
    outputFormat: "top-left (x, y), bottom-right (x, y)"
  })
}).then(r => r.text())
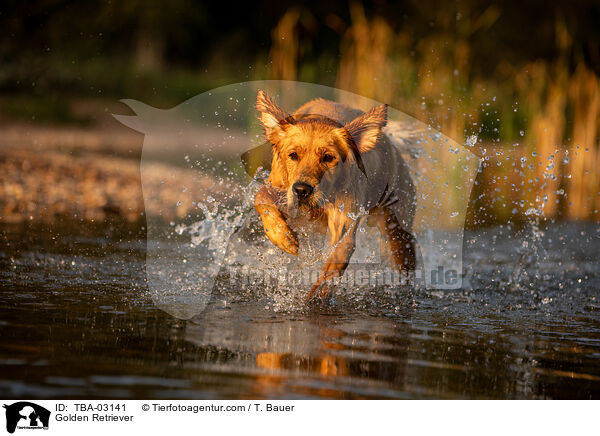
top-left (306, 220), bottom-right (358, 301)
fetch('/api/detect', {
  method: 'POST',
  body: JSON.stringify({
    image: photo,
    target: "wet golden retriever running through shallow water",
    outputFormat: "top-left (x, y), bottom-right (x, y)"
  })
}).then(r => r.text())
top-left (254, 90), bottom-right (416, 300)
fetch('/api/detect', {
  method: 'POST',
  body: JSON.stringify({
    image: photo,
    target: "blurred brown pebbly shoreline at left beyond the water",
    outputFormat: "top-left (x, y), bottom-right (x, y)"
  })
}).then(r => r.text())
top-left (0, 126), bottom-right (233, 223)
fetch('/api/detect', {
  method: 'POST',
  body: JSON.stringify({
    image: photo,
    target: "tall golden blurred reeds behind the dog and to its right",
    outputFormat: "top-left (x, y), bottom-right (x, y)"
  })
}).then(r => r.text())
top-left (271, 2), bottom-right (600, 226)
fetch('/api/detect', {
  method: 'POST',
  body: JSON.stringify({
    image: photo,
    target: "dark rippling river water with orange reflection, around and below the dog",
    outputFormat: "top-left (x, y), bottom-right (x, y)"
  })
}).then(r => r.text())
top-left (0, 223), bottom-right (600, 399)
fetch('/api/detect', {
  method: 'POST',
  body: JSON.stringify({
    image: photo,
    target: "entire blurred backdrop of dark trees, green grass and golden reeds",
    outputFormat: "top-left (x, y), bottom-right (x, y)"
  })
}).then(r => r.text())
top-left (0, 0), bottom-right (600, 225)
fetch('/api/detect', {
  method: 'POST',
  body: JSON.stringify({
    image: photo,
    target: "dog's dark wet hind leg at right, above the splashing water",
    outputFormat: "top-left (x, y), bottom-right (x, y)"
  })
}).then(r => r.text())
top-left (376, 208), bottom-right (416, 272)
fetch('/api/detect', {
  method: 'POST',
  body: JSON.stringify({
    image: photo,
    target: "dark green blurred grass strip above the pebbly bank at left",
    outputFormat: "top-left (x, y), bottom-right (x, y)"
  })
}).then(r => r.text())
top-left (0, 56), bottom-right (247, 125)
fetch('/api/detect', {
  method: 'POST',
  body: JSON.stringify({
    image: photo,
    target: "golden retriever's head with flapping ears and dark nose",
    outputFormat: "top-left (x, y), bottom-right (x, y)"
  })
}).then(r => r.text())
top-left (256, 91), bottom-right (387, 214)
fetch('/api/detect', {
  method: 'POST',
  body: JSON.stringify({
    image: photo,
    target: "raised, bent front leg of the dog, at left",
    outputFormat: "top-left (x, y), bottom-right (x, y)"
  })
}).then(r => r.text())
top-left (254, 185), bottom-right (298, 256)
